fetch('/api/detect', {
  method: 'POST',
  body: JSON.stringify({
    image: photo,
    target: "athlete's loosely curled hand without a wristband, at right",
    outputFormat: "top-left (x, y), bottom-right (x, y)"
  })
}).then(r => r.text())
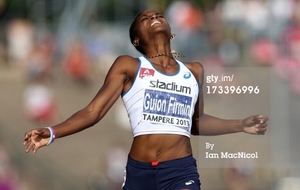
top-left (242, 115), bottom-right (268, 135)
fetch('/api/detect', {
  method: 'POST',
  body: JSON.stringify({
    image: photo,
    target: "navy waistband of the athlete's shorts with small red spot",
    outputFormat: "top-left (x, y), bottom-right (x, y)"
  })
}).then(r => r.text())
top-left (127, 155), bottom-right (195, 169)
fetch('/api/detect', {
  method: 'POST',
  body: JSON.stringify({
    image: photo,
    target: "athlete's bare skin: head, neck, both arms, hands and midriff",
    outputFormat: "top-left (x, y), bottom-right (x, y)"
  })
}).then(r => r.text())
top-left (23, 10), bottom-right (268, 190)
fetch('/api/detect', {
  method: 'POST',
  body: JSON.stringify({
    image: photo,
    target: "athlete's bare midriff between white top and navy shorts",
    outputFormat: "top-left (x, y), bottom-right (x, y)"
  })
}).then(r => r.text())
top-left (129, 134), bottom-right (192, 162)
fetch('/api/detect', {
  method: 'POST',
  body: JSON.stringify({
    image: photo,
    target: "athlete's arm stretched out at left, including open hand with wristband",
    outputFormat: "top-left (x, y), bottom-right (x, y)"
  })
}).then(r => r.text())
top-left (23, 56), bottom-right (133, 153)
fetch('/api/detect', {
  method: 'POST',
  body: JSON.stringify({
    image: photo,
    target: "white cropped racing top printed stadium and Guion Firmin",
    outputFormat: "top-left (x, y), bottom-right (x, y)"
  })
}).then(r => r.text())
top-left (122, 57), bottom-right (199, 137)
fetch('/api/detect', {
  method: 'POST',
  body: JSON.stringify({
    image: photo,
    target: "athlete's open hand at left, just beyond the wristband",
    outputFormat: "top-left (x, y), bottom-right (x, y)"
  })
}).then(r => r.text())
top-left (23, 128), bottom-right (50, 153)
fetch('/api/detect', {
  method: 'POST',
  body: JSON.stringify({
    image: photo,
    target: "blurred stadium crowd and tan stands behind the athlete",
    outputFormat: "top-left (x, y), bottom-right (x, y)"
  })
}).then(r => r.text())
top-left (0, 0), bottom-right (300, 190)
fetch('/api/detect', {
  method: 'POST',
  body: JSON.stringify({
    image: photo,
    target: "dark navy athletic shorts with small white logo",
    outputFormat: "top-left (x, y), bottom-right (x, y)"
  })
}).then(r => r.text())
top-left (123, 156), bottom-right (201, 190)
